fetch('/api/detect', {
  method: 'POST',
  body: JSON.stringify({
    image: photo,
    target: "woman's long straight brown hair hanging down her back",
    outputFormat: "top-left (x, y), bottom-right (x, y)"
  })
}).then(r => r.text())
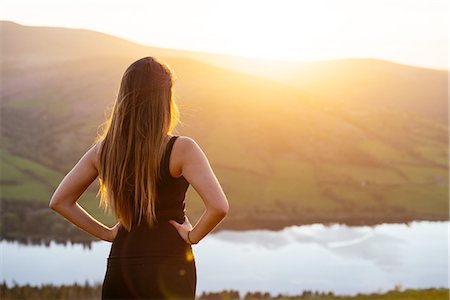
top-left (94, 57), bottom-right (179, 231)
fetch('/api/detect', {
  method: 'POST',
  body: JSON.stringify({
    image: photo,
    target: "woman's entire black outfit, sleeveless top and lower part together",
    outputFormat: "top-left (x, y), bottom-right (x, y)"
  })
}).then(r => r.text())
top-left (102, 136), bottom-right (197, 299)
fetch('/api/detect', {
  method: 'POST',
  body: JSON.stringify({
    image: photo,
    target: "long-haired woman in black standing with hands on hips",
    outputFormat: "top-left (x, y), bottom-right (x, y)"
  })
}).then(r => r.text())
top-left (50, 57), bottom-right (229, 299)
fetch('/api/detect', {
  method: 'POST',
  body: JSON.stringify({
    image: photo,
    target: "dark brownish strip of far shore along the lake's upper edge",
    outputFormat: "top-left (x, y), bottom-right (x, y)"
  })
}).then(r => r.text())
top-left (0, 199), bottom-right (449, 247)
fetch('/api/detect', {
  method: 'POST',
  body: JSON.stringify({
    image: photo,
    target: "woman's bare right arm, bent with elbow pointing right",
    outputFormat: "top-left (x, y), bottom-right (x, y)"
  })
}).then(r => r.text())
top-left (171, 137), bottom-right (229, 244)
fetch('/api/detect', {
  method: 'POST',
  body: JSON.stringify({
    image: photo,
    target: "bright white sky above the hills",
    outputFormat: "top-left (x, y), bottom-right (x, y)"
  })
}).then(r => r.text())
top-left (0, 0), bottom-right (450, 70)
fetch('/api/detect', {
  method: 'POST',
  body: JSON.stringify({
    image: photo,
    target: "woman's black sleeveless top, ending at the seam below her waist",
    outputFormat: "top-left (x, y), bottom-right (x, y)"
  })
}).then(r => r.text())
top-left (108, 136), bottom-right (192, 261)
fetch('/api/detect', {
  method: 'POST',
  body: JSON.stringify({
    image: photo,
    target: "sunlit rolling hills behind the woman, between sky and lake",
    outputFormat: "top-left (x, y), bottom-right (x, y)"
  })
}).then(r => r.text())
top-left (0, 21), bottom-right (449, 241)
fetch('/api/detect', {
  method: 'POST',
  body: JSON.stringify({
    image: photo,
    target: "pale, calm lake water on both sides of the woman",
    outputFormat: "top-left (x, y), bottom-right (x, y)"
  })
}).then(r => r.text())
top-left (0, 221), bottom-right (449, 297)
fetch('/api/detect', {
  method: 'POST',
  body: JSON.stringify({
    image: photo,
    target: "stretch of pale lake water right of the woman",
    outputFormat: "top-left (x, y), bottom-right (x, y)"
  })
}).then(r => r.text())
top-left (192, 222), bottom-right (449, 295)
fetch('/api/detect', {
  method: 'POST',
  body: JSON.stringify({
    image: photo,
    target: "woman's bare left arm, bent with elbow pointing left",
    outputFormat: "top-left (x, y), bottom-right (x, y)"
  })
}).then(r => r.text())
top-left (49, 147), bottom-right (118, 242)
